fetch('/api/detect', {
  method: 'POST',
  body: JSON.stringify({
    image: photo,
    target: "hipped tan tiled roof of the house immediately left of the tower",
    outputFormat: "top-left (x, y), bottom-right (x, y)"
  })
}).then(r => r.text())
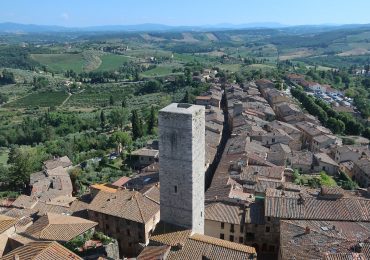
top-left (89, 189), bottom-right (159, 223)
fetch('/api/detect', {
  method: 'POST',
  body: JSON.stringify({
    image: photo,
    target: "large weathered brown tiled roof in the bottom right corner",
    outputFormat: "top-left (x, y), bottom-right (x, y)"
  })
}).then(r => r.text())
top-left (280, 220), bottom-right (370, 260)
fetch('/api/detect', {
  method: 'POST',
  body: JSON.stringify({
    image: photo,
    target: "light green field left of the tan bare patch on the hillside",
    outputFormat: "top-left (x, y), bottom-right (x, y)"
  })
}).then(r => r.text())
top-left (31, 53), bottom-right (85, 72)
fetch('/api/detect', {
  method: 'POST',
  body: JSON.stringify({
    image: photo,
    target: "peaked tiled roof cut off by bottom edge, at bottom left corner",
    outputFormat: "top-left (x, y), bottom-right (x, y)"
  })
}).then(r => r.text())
top-left (1, 242), bottom-right (82, 260)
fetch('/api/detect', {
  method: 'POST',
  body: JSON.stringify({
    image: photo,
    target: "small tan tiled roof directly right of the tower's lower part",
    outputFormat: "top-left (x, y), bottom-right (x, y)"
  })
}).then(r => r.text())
top-left (204, 202), bottom-right (244, 225)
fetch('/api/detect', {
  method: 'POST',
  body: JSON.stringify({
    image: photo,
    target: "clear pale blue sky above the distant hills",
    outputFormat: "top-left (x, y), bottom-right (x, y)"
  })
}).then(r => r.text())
top-left (0, 0), bottom-right (370, 27)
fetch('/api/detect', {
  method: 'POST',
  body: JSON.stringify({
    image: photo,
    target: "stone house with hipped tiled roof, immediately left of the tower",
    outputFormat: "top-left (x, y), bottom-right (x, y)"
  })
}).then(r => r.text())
top-left (88, 186), bottom-right (160, 257)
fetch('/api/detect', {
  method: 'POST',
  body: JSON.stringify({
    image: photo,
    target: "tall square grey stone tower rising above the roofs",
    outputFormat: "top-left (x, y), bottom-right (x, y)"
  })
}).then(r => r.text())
top-left (158, 103), bottom-right (205, 234)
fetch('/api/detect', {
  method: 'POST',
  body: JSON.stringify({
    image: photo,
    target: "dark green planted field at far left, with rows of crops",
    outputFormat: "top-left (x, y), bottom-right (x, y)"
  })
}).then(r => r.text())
top-left (4, 92), bottom-right (68, 108)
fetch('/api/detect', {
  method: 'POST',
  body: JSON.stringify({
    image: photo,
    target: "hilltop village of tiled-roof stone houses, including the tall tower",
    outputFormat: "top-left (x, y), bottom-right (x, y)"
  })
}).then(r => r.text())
top-left (0, 69), bottom-right (370, 260)
